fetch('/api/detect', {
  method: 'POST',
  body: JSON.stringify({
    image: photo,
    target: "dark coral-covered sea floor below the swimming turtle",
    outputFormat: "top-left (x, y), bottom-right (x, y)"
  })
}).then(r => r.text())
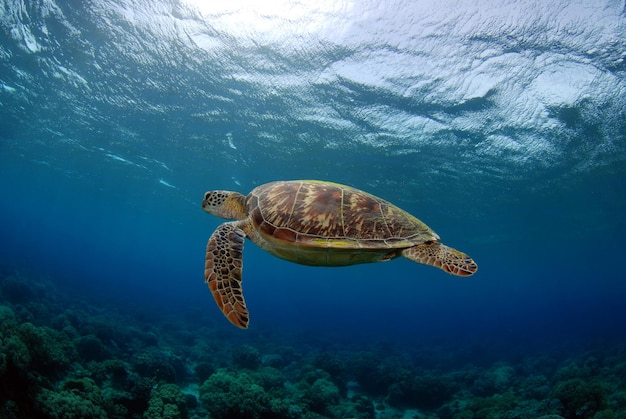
top-left (0, 268), bottom-right (626, 419)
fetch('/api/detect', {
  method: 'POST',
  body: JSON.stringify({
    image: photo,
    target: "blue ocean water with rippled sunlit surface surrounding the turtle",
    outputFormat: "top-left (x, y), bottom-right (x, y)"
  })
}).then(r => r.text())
top-left (0, 0), bottom-right (626, 417)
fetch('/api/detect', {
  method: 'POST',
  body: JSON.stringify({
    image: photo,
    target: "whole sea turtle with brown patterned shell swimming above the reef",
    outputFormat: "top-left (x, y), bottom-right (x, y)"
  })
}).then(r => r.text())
top-left (202, 180), bottom-right (478, 329)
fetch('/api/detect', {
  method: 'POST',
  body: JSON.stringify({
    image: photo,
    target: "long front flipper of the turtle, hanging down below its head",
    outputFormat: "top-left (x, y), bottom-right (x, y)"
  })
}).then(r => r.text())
top-left (204, 223), bottom-right (249, 329)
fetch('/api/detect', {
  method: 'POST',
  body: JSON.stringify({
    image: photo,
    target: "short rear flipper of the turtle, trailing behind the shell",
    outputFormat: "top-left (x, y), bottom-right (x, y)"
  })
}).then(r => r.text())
top-left (402, 241), bottom-right (478, 276)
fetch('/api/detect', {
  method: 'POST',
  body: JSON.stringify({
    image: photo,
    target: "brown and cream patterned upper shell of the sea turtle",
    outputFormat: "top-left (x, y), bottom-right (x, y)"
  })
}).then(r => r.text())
top-left (247, 181), bottom-right (438, 247)
